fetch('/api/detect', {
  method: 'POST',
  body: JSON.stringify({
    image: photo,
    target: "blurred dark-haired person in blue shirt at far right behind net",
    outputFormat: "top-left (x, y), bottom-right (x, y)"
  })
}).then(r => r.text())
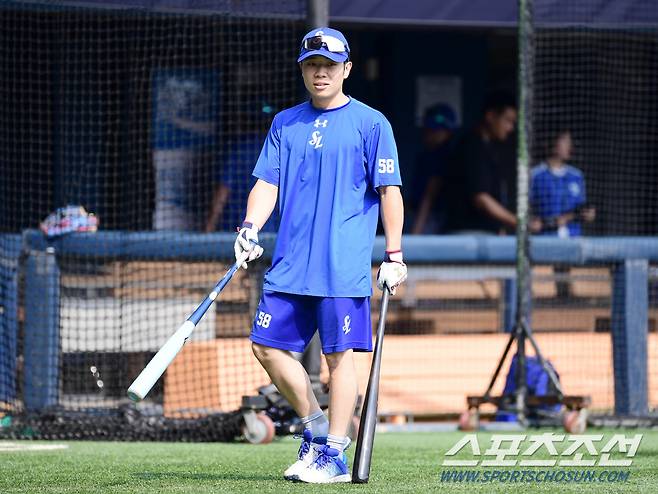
top-left (530, 130), bottom-right (596, 238)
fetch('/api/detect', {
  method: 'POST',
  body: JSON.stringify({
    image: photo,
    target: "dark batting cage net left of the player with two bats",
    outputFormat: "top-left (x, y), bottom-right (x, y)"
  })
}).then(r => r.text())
top-left (0, 0), bottom-right (306, 440)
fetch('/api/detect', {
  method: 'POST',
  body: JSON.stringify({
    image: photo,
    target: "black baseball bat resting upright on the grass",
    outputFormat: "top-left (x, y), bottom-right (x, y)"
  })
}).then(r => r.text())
top-left (352, 287), bottom-right (388, 484)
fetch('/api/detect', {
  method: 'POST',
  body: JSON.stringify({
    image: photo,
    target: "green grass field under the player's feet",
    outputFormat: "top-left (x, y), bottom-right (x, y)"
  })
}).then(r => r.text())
top-left (0, 429), bottom-right (658, 494)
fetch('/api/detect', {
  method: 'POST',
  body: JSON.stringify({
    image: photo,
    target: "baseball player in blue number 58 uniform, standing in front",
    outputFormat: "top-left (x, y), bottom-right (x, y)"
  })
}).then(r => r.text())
top-left (235, 27), bottom-right (407, 483)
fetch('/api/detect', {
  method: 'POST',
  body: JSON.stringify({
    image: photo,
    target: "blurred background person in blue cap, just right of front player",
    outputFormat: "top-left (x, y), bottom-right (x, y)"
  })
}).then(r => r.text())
top-left (411, 103), bottom-right (457, 235)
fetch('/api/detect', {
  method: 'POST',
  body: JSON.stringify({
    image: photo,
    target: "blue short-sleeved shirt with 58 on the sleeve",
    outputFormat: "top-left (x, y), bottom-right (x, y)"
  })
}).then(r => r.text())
top-left (253, 98), bottom-right (402, 297)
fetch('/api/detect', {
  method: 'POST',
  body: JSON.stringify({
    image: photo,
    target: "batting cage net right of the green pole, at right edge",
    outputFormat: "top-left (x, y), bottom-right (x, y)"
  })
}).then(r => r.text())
top-left (510, 0), bottom-right (658, 424)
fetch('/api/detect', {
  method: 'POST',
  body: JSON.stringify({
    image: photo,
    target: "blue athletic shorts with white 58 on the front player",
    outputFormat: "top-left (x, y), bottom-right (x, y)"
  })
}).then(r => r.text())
top-left (250, 290), bottom-right (372, 354)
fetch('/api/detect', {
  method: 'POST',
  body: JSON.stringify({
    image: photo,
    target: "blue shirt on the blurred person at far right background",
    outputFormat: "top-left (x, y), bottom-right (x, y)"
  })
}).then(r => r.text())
top-left (530, 163), bottom-right (586, 237)
